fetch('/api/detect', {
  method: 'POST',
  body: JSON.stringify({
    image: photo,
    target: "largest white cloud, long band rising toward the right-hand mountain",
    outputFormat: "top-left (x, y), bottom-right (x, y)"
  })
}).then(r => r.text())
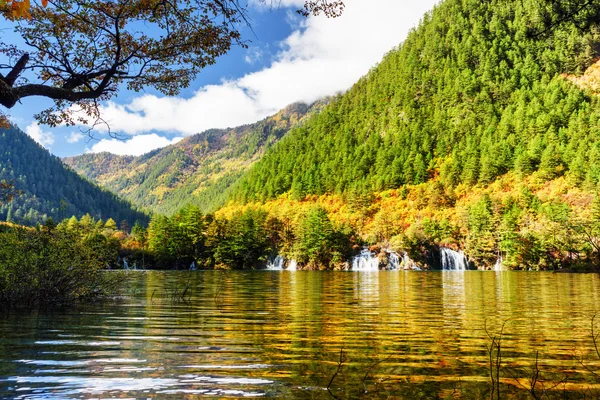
top-left (94, 0), bottom-right (436, 138)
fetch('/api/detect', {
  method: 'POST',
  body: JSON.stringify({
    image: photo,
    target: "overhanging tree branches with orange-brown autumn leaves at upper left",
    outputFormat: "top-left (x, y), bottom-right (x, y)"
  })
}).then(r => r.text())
top-left (0, 0), bottom-right (344, 130)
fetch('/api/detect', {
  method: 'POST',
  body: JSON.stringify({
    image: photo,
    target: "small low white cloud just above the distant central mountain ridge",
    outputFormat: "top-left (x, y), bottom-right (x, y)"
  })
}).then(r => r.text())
top-left (86, 133), bottom-right (182, 156)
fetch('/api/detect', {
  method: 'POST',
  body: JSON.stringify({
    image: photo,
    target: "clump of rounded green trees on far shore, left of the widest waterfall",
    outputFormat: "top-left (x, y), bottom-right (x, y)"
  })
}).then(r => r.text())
top-left (141, 205), bottom-right (353, 270)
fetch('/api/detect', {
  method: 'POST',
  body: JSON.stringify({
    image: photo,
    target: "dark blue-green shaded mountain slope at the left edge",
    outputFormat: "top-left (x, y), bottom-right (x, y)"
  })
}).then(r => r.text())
top-left (0, 127), bottom-right (148, 226)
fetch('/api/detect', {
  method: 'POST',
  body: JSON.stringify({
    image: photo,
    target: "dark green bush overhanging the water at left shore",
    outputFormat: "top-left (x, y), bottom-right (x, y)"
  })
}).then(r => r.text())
top-left (0, 228), bottom-right (122, 308)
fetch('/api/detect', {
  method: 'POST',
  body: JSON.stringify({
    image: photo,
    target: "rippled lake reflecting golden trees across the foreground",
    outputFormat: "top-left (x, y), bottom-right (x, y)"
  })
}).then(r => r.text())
top-left (0, 271), bottom-right (600, 399)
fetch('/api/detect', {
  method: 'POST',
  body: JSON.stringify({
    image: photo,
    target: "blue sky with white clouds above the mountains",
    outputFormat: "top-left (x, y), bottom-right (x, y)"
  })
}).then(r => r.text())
top-left (0, 0), bottom-right (437, 157)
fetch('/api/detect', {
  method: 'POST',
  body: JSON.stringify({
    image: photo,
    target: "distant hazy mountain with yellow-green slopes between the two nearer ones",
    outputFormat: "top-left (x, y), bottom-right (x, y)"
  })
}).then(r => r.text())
top-left (63, 100), bottom-right (327, 214)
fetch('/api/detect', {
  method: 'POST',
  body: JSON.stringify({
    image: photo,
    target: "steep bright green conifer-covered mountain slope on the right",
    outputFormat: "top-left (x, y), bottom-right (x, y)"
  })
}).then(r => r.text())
top-left (232, 0), bottom-right (600, 202)
